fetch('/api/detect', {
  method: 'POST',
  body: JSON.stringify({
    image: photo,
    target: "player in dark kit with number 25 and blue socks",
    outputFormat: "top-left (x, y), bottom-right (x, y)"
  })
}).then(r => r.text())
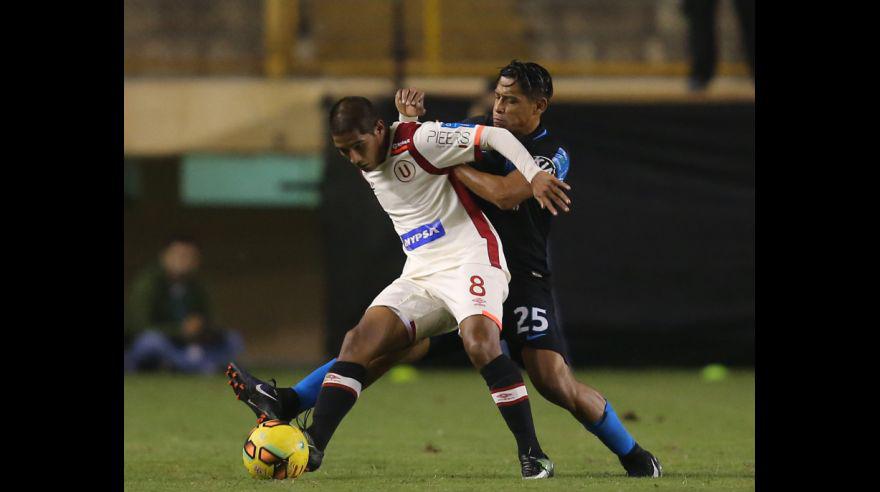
top-left (227, 60), bottom-right (662, 477)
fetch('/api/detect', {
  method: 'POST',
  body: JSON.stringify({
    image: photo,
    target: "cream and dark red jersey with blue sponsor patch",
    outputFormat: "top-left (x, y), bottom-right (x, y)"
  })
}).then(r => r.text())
top-left (363, 122), bottom-right (510, 281)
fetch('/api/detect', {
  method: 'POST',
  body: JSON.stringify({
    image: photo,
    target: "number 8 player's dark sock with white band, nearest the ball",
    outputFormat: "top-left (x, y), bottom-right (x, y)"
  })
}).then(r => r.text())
top-left (308, 361), bottom-right (367, 451)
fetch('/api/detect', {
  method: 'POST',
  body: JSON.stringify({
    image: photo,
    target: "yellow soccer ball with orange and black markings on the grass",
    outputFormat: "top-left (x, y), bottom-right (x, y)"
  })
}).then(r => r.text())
top-left (241, 420), bottom-right (309, 480)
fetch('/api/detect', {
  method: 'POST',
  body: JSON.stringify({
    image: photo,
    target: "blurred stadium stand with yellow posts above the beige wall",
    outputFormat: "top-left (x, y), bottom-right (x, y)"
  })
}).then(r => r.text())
top-left (124, 0), bottom-right (747, 77)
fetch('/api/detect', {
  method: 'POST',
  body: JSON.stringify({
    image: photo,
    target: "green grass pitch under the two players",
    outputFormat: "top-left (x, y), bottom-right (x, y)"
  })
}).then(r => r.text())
top-left (124, 370), bottom-right (755, 492)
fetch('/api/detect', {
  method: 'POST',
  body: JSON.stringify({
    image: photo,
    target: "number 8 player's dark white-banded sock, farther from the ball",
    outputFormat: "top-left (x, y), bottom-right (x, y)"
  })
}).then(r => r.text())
top-left (480, 354), bottom-right (544, 457)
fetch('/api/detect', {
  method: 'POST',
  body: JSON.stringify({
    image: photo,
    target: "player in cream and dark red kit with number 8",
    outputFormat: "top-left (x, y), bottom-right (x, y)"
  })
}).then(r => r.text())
top-left (230, 97), bottom-right (570, 479)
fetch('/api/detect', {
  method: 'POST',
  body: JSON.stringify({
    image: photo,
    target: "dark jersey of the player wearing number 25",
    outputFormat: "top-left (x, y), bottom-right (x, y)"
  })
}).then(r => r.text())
top-left (465, 115), bottom-right (569, 278)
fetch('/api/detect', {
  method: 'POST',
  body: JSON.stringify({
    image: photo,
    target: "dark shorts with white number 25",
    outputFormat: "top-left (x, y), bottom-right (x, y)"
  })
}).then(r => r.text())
top-left (501, 275), bottom-right (571, 365)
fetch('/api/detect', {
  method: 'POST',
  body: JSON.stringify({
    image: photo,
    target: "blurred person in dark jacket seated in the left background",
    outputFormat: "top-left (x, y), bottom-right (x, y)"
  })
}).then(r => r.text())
top-left (125, 237), bottom-right (244, 374)
